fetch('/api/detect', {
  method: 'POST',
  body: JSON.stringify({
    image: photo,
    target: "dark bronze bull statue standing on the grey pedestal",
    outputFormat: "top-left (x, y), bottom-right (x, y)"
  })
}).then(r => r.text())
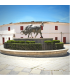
top-left (20, 22), bottom-right (44, 38)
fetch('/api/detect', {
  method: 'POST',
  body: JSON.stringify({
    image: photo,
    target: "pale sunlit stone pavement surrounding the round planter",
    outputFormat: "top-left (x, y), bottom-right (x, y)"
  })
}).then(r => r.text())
top-left (0, 44), bottom-right (70, 75)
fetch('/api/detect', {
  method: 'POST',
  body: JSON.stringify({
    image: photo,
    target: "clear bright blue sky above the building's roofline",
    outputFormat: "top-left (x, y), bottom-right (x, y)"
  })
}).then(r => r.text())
top-left (0, 5), bottom-right (69, 25)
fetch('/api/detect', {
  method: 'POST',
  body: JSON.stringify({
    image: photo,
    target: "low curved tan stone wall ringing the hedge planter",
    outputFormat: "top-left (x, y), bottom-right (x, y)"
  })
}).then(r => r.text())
top-left (0, 49), bottom-right (68, 57)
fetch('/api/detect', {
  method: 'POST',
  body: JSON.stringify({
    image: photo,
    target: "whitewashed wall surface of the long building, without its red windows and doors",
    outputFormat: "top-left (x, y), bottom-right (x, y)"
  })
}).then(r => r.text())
top-left (0, 23), bottom-right (70, 43)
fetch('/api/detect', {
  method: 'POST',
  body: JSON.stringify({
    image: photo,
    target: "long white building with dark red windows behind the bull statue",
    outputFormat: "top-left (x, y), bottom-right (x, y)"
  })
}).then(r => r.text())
top-left (0, 22), bottom-right (70, 44)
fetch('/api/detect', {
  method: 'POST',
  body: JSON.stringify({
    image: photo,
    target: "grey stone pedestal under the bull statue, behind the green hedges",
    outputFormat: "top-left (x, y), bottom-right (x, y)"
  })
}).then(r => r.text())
top-left (13, 38), bottom-right (53, 50)
